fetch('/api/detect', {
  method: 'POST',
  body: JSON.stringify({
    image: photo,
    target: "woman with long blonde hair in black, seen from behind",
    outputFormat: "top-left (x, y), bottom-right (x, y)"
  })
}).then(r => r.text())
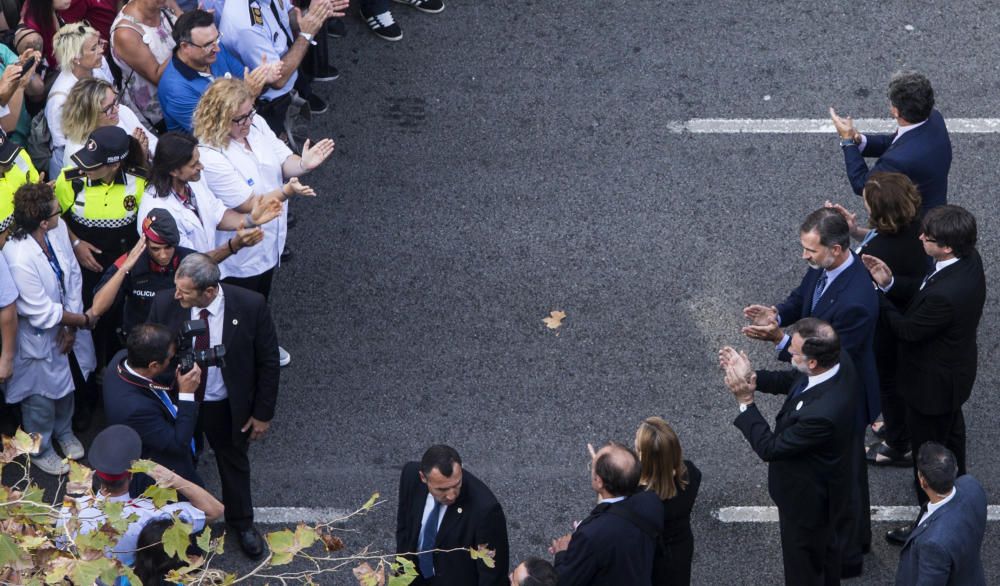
top-left (635, 417), bottom-right (701, 586)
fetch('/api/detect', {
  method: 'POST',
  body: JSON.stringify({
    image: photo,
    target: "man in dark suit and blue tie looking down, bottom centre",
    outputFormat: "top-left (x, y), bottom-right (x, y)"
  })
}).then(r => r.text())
top-left (396, 445), bottom-right (510, 586)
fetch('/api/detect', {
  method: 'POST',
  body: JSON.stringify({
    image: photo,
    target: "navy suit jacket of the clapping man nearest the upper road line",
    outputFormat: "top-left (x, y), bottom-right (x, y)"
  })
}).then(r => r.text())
top-left (841, 110), bottom-right (951, 213)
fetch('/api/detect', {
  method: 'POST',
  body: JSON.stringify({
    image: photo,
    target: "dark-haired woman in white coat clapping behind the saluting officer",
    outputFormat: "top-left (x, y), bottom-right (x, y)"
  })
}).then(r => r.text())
top-left (136, 132), bottom-right (282, 274)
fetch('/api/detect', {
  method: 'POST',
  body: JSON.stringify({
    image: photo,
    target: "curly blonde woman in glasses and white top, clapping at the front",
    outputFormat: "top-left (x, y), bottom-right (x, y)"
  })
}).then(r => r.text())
top-left (194, 79), bottom-right (334, 366)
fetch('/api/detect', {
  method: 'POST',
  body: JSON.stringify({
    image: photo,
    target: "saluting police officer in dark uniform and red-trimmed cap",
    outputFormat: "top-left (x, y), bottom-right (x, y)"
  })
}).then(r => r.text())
top-left (91, 208), bottom-right (195, 337)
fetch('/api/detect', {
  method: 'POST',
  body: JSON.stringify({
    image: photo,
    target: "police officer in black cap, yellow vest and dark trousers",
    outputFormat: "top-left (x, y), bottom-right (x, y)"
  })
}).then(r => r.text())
top-left (55, 126), bottom-right (146, 431)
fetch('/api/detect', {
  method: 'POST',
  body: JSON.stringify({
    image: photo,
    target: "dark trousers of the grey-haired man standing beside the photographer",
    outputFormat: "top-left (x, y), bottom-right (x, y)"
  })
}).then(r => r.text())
top-left (198, 399), bottom-right (253, 531)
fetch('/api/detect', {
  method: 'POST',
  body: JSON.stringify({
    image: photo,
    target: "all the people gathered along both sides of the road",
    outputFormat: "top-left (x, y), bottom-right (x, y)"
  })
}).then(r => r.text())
top-left (0, 0), bottom-right (986, 585)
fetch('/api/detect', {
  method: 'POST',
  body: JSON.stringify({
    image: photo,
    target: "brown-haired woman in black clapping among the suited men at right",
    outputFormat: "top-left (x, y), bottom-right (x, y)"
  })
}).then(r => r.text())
top-left (828, 173), bottom-right (930, 467)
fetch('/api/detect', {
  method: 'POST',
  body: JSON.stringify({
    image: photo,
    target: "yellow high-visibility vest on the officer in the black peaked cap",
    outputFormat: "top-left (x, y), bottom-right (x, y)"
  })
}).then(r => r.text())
top-left (55, 168), bottom-right (146, 228)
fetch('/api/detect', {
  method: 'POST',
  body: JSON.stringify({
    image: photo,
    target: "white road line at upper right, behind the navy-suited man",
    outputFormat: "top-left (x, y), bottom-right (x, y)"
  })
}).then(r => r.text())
top-left (668, 118), bottom-right (1000, 134)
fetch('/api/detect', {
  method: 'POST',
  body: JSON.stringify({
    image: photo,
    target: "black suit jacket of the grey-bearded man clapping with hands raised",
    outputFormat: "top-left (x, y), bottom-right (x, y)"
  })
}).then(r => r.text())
top-left (734, 352), bottom-right (859, 528)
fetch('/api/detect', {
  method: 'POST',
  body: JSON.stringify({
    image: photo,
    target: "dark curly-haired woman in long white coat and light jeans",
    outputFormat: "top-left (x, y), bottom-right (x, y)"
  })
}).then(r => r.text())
top-left (3, 183), bottom-right (97, 475)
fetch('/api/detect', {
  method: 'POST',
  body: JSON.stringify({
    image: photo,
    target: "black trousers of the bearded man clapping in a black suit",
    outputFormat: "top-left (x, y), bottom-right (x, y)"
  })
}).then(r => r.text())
top-left (778, 509), bottom-right (840, 586)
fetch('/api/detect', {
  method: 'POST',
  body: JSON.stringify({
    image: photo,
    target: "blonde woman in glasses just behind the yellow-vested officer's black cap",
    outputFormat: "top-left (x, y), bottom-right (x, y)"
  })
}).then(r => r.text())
top-left (62, 77), bottom-right (156, 161)
